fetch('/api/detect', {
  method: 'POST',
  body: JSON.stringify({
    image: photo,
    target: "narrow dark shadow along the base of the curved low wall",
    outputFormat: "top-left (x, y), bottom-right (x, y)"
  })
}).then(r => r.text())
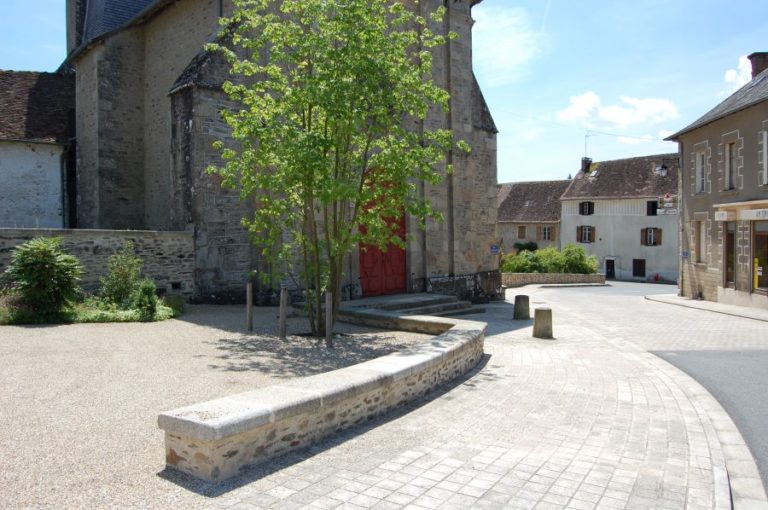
top-left (157, 354), bottom-right (496, 498)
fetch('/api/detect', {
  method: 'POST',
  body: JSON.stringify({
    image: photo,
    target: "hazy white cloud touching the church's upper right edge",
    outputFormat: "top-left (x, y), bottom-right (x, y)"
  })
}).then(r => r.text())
top-left (472, 4), bottom-right (545, 87)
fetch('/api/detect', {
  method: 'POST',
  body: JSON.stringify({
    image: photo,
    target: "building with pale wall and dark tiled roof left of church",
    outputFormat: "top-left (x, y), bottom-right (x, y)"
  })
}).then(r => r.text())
top-left (0, 71), bottom-right (75, 228)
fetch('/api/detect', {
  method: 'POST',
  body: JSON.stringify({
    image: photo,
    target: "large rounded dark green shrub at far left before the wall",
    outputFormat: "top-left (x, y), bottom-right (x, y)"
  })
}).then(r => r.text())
top-left (5, 237), bottom-right (83, 317)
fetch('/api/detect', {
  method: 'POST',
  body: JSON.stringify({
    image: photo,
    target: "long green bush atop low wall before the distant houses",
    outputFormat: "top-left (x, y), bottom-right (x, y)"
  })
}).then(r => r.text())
top-left (501, 244), bottom-right (598, 274)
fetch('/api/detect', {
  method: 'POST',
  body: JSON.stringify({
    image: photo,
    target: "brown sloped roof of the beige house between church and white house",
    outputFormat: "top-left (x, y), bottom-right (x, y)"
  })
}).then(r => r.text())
top-left (498, 181), bottom-right (571, 223)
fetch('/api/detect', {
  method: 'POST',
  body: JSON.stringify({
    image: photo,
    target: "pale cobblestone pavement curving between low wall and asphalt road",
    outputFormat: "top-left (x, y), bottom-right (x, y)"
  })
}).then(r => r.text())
top-left (190, 284), bottom-right (768, 509)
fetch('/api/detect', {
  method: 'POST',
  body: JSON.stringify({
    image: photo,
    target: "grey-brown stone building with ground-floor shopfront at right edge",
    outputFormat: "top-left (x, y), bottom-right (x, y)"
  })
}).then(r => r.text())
top-left (668, 52), bottom-right (768, 308)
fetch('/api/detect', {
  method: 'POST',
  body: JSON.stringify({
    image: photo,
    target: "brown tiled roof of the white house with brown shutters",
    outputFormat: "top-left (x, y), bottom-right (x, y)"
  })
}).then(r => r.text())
top-left (562, 152), bottom-right (679, 200)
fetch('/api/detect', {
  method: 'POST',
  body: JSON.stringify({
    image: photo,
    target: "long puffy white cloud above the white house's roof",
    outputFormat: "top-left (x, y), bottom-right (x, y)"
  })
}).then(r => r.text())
top-left (557, 91), bottom-right (680, 129)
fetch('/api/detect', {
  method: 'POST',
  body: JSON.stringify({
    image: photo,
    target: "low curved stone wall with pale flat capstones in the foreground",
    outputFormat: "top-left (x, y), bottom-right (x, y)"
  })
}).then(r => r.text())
top-left (158, 312), bottom-right (486, 481)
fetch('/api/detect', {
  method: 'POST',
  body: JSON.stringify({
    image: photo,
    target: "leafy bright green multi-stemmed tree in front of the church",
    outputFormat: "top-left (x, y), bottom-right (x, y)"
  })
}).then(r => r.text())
top-left (209, 0), bottom-right (469, 347)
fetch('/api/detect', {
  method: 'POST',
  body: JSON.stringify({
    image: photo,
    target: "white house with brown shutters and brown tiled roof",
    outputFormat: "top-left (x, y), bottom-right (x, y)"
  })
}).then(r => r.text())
top-left (560, 154), bottom-right (679, 282)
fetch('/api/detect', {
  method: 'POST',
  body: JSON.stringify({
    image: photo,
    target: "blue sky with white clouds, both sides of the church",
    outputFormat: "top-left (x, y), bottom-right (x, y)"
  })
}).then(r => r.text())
top-left (0, 0), bottom-right (768, 182)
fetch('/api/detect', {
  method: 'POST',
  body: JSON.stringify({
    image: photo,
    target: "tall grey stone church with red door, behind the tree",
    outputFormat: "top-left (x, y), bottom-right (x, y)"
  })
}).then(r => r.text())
top-left (65, 0), bottom-right (499, 301)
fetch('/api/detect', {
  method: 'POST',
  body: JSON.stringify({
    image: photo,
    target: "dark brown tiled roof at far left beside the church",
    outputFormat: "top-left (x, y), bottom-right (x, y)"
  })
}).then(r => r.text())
top-left (0, 71), bottom-right (75, 143)
